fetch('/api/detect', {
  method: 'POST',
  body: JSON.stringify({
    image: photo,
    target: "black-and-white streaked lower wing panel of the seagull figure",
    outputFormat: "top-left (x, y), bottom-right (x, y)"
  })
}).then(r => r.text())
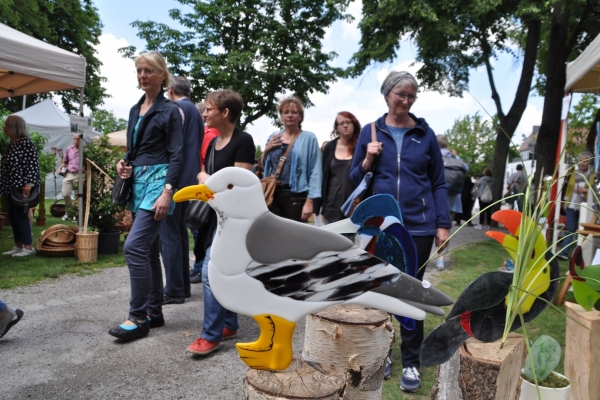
top-left (246, 246), bottom-right (405, 301)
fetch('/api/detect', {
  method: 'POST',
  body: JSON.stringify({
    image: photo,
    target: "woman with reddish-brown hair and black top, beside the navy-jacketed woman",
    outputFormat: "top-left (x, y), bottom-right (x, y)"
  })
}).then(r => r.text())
top-left (315, 111), bottom-right (361, 223)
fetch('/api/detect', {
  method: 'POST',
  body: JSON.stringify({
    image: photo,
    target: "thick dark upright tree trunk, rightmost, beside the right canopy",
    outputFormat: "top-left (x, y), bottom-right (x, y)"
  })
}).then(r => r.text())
top-left (534, 0), bottom-right (570, 186)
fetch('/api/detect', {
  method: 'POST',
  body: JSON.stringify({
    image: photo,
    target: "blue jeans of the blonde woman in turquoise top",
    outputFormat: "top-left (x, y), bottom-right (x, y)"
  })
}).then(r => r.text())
top-left (123, 209), bottom-right (164, 321)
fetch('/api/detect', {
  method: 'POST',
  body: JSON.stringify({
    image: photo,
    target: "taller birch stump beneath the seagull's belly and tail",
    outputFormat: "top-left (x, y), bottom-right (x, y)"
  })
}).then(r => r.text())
top-left (302, 304), bottom-right (394, 400)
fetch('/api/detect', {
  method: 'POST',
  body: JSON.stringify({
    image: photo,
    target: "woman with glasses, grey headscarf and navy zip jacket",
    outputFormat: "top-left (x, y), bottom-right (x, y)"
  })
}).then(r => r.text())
top-left (350, 71), bottom-right (451, 392)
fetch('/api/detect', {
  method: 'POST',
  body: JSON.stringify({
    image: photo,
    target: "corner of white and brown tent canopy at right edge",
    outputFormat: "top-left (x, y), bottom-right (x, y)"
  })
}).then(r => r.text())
top-left (565, 35), bottom-right (600, 93)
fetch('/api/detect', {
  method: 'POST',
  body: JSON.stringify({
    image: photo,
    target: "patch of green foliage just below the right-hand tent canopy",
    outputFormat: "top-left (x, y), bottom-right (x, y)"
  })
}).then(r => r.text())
top-left (565, 93), bottom-right (600, 164)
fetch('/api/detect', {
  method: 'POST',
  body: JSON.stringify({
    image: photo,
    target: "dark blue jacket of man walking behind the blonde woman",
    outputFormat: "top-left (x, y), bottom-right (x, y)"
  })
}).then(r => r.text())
top-left (174, 97), bottom-right (204, 189)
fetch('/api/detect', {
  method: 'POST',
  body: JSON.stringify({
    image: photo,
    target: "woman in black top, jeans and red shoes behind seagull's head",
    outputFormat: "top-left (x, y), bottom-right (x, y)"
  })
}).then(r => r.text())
top-left (187, 90), bottom-right (256, 355)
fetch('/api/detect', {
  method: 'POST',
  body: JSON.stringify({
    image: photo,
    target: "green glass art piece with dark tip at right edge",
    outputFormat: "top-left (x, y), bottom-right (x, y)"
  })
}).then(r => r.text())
top-left (569, 242), bottom-right (600, 311)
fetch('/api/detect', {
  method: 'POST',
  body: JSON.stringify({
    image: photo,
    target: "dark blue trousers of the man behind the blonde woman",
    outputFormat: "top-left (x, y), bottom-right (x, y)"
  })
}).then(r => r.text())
top-left (160, 202), bottom-right (191, 297)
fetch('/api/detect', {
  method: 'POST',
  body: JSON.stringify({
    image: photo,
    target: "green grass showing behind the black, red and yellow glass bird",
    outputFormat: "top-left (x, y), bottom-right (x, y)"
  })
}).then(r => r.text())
top-left (382, 241), bottom-right (574, 400)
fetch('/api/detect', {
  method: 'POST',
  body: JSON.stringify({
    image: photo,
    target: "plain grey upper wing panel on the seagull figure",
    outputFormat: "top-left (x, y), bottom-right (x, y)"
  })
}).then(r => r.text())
top-left (246, 212), bottom-right (353, 264)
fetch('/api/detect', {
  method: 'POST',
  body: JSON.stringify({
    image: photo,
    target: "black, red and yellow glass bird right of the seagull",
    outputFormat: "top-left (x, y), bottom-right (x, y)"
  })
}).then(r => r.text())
top-left (421, 210), bottom-right (559, 366)
